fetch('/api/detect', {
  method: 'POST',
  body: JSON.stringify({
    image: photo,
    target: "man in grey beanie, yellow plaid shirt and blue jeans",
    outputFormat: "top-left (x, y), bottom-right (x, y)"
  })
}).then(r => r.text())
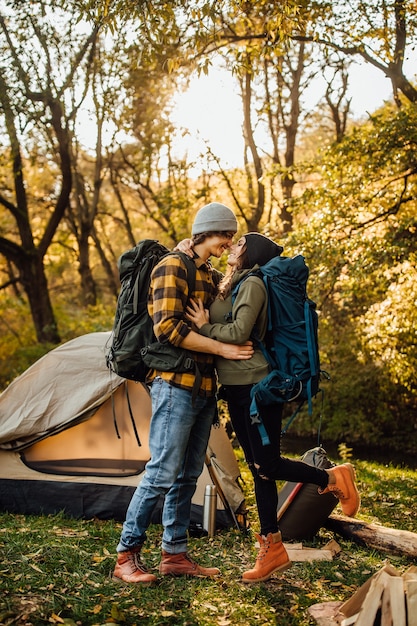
top-left (113, 202), bottom-right (253, 584)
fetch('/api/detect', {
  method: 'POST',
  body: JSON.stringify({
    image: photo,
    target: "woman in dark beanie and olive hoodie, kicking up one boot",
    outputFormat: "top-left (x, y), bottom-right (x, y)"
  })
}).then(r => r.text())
top-left (187, 233), bottom-right (360, 583)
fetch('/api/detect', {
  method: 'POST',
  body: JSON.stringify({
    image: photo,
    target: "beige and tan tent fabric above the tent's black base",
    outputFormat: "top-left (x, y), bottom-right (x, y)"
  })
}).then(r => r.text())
top-left (0, 332), bottom-right (244, 511)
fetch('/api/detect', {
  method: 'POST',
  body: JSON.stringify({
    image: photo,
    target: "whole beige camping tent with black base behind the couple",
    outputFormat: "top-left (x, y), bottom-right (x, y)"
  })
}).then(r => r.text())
top-left (0, 332), bottom-right (244, 527)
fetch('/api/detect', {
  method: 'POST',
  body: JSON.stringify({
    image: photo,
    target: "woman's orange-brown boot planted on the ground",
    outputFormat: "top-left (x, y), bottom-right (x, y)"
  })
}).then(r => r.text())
top-left (242, 531), bottom-right (292, 583)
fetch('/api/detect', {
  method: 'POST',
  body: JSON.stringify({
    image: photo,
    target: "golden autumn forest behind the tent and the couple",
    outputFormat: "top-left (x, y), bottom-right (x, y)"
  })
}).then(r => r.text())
top-left (0, 0), bottom-right (417, 459)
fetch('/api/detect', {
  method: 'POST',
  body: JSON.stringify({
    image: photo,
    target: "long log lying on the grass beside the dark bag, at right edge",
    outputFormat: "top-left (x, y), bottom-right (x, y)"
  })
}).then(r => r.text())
top-left (325, 515), bottom-right (417, 557)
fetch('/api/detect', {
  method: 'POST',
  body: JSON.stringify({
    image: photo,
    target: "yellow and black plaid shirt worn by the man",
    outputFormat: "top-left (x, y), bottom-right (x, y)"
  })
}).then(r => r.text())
top-left (148, 254), bottom-right (221, 396)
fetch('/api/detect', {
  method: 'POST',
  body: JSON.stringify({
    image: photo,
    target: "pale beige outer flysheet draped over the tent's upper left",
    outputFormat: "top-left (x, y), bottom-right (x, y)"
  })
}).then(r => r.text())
top-left (0, 332), bottom-right (124, 450)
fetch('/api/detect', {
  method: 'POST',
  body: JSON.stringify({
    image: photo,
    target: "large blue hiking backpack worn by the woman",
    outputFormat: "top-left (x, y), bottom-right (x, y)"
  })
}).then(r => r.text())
top-left (232, 255), bottom-right (327, 445)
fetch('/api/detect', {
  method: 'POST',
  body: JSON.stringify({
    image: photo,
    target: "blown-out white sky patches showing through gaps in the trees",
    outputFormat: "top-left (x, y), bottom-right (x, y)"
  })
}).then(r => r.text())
top-left (172, 64), bottom-right (410, 166)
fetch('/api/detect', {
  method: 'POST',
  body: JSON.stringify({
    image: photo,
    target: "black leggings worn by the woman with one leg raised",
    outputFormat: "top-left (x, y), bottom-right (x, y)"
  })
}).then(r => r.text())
top-left (221, 385), bottom-right (328, 535)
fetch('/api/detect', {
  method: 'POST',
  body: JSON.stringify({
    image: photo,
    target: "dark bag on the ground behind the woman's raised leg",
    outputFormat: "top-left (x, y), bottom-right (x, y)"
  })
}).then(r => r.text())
top-left (278, 447), bottom-right (339, 541)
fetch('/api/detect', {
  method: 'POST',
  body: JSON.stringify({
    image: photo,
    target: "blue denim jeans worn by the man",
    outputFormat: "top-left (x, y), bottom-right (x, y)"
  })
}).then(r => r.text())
top-left (117, 378), bottom-right (216, 554)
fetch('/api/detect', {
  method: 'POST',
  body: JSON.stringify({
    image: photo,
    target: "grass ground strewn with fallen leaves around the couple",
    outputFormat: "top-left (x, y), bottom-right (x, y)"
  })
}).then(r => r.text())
top-left (0, 454), bottom-right (417, 626)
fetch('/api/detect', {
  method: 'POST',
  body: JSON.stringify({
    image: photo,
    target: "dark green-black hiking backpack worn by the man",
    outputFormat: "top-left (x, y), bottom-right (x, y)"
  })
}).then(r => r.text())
top-left (106, 239), bottom-right (196, 382)
